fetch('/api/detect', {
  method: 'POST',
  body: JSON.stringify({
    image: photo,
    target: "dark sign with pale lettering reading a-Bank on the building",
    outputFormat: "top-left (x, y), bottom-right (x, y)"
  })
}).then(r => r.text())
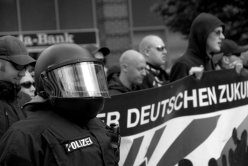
top-left (15, 30), bottom-right (98, 52)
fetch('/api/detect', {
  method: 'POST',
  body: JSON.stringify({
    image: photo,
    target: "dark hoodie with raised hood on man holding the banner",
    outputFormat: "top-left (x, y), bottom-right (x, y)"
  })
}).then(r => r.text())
top-left (170, 13), bottom-right (224, 81)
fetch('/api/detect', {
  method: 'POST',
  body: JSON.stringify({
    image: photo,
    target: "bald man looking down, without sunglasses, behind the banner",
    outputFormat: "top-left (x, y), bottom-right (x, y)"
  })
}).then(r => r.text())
top-left (108, 50), bottom-right (146, 95)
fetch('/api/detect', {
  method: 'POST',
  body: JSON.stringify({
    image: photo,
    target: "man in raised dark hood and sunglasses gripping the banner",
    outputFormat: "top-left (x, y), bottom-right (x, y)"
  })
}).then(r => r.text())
top-left (170, 13), bottom-right (225, 81)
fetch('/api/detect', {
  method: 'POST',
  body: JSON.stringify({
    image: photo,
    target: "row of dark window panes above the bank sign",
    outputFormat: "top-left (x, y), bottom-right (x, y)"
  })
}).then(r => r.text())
top-left (0, 0), bottom-right (96, 33)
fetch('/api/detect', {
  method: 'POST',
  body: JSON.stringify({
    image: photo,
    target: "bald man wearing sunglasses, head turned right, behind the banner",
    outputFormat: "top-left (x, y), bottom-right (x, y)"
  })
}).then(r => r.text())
top-left (139, 35), bottom-right (169, 88)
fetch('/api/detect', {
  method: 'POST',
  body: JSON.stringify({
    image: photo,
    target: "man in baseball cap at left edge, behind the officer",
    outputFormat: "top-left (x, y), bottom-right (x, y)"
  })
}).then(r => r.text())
top-left (0, 36), bottom-right (35, 138)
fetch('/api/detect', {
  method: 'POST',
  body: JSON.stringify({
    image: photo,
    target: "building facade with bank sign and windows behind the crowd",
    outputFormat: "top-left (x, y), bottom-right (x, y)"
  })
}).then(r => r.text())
top-left (0, 0), bottom-right (179, 65)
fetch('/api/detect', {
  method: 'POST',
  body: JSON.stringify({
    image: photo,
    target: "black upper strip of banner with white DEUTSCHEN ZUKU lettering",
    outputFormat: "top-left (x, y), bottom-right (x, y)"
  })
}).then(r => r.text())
top-left (98, 70), bottom-right (248, 136)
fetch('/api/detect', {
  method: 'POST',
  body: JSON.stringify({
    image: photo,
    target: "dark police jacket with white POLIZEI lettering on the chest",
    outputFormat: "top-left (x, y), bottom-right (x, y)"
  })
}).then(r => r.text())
top-left (0, 104), bottom-right (119, 166)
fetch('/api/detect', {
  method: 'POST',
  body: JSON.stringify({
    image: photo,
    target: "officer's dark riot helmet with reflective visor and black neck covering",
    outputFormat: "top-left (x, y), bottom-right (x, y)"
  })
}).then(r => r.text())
top-left (35, 44), bottom-right (109, 119)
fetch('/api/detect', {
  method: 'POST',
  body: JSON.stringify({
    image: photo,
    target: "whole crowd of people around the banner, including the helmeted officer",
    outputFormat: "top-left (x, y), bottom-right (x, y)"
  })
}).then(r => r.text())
top-left (0, 13), bottom-right (248, 166)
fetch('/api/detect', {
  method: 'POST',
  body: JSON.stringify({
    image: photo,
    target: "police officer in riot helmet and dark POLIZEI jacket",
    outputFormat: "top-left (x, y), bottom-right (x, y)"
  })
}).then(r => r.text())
top-left (0, 44), bottom-right (120, 166)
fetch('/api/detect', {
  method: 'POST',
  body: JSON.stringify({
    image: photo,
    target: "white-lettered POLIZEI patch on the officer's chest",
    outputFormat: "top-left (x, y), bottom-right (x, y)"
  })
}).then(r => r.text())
top-left (64, 137), bottom-right (93, 152)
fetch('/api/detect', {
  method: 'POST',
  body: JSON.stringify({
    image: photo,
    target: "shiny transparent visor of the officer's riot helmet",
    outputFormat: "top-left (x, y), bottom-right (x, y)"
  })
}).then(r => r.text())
top-left (43, 62), bottom-right (109, 98)
